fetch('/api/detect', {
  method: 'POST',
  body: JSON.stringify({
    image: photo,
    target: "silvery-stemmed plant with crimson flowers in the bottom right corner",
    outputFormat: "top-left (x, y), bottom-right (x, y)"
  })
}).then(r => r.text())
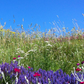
top-left (72, 61), bottom-right (84, 84)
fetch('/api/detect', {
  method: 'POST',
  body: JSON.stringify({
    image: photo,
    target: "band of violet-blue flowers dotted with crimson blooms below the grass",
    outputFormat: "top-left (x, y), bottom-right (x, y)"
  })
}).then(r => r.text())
top-left (0, 56), bottom-right (80, 84)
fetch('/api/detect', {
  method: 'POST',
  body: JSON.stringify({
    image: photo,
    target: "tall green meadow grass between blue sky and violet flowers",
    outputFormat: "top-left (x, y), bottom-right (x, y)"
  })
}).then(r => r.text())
top-left (0, 21), bottom-right (84, 75)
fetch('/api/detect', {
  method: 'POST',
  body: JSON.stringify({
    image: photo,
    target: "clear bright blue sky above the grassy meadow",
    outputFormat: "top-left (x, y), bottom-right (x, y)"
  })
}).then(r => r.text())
top-left (0, 0), bottom-right (84, 38)
